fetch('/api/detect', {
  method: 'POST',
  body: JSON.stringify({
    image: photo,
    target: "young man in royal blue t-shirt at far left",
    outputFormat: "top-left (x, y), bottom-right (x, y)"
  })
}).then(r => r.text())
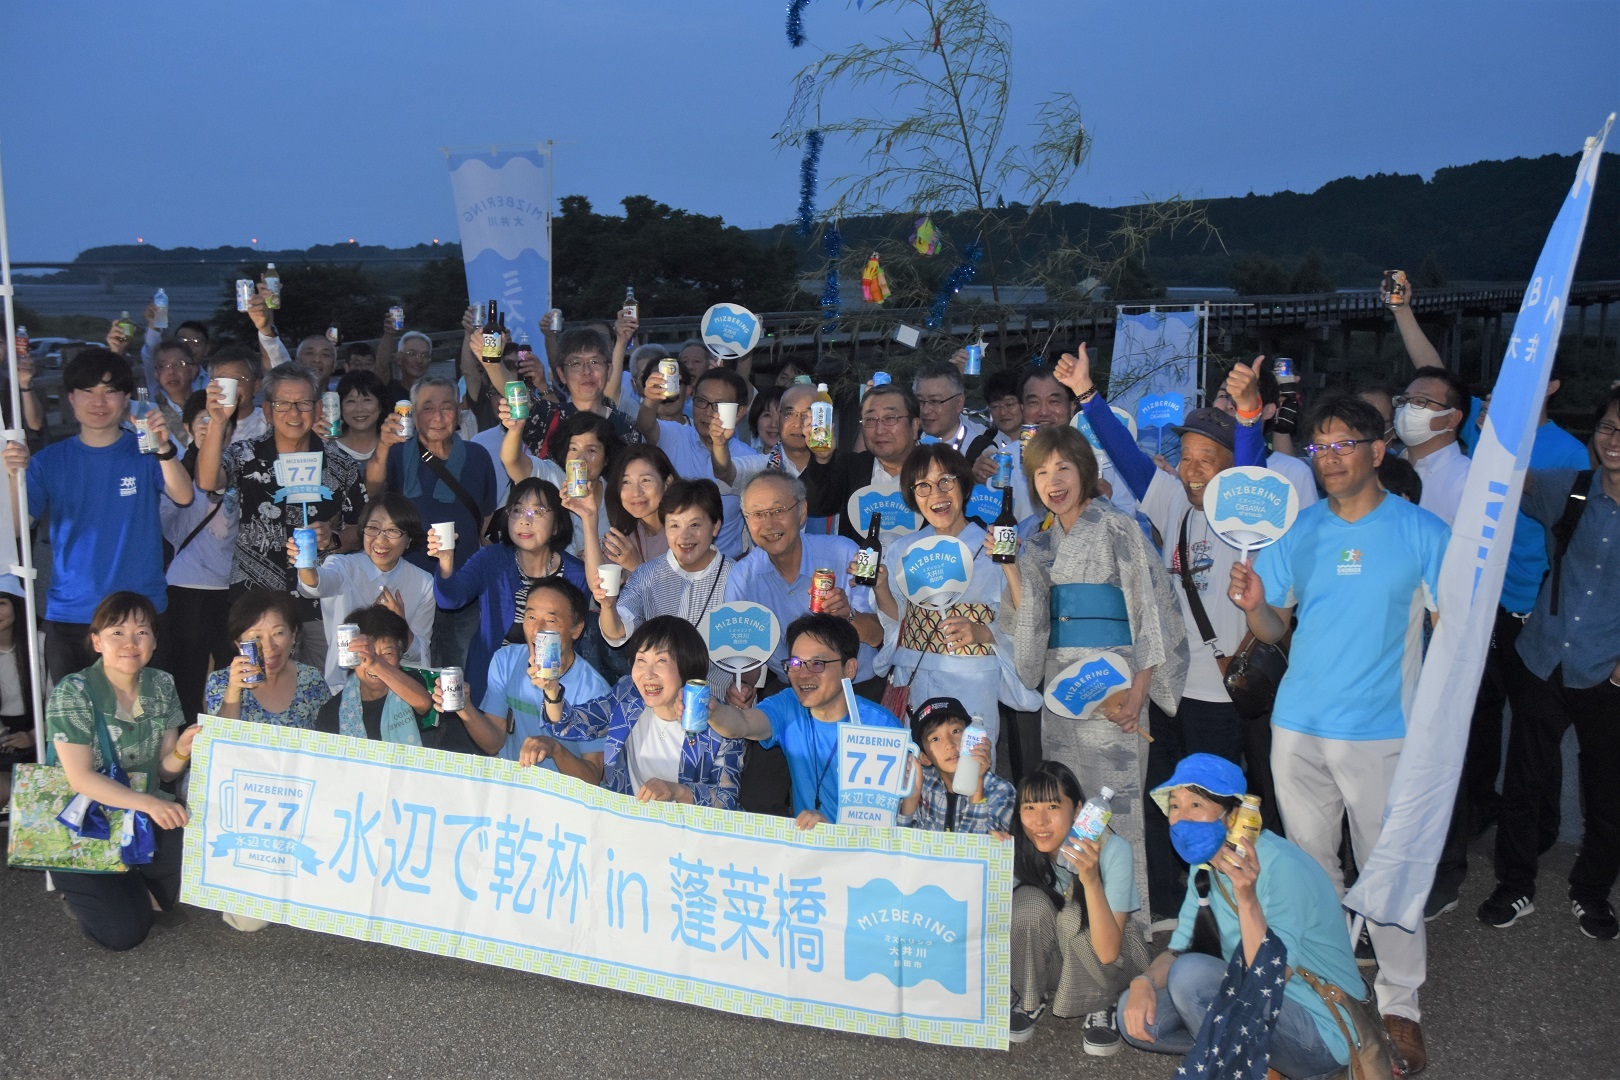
top-left (5, 348), bottom-right (193, 682)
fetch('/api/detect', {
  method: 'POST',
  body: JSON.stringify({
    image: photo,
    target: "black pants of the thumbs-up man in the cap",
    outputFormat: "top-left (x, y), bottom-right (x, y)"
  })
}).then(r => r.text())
top-left (1142, 698), bottom-right (1252, 916)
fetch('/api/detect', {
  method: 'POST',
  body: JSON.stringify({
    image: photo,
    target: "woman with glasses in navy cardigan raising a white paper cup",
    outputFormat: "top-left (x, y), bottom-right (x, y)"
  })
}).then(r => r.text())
top-left (428, 476), bottom-right (585, 753)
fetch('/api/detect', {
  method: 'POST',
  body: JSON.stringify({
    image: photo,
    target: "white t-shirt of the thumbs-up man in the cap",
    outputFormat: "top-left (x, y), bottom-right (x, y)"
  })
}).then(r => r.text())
top-left (1142, 470), bottom-right (1247, 701)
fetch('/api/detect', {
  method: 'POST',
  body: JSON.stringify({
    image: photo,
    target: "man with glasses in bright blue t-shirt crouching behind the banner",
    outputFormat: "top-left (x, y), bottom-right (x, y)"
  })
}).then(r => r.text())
top-left (710, 615), bottom-right (901, 829)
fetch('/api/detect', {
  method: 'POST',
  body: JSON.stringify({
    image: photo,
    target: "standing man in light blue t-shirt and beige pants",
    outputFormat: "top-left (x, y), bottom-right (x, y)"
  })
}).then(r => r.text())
top-left (1231, 393), bottom-right (1450, 1072)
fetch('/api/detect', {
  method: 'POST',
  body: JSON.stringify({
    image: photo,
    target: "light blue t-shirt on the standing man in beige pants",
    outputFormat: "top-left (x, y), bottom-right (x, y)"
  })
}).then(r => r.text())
top-left (1254, 494), bottom-right (1452, 740)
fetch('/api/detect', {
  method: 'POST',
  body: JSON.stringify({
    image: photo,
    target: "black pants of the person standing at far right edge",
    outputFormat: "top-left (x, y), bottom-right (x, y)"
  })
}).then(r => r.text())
top-left (1497, 651), bottom-right (1620, 905)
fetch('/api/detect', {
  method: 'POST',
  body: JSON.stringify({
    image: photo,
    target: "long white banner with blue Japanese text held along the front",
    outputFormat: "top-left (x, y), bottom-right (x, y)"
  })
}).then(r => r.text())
top-left (181, 717), bottom-right (1013, 1048)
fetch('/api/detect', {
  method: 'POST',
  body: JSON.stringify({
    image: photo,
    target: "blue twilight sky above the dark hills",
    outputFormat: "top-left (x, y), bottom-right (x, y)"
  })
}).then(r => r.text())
top-left (0, 0), bottom-right (1620, 259)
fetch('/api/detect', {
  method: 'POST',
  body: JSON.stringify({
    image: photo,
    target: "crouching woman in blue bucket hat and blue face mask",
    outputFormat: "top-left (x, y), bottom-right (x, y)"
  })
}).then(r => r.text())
top-left (1119, 755), bottom-right (1367, 1080)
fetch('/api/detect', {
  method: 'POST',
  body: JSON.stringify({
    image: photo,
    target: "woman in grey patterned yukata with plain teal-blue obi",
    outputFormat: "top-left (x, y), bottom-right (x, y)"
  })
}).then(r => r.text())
top-left (1001, 426), bottom-right (1187, 932)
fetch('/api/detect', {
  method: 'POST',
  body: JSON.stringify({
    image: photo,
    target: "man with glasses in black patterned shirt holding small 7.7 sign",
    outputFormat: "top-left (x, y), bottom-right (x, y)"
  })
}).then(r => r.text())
top-left (196, 364), bottom-right (366, 669)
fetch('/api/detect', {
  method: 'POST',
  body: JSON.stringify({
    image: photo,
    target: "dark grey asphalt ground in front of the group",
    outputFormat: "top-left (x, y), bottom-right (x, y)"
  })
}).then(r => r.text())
top-left (0, 834), bottom-right (1620, 1080)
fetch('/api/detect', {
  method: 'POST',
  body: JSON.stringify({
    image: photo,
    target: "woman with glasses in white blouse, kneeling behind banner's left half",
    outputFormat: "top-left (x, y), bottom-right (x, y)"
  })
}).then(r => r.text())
top-left (287, 492), bottom-right (439, 693)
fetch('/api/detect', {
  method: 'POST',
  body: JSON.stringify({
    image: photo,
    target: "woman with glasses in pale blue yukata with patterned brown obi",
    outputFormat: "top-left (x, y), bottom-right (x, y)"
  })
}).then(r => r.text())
top-left (874, 442), bottom-right (1040, 755)
